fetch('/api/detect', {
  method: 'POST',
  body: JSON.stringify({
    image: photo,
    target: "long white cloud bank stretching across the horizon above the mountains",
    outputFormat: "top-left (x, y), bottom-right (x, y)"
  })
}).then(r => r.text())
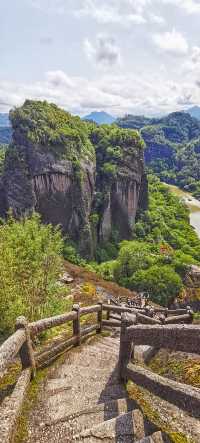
top-left (0, 67), bottom-right (200, 115)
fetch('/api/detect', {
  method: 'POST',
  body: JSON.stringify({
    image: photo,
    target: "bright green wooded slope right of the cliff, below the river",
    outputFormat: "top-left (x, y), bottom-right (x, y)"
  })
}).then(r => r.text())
top-left (89, 176), bottom-right (200, 306)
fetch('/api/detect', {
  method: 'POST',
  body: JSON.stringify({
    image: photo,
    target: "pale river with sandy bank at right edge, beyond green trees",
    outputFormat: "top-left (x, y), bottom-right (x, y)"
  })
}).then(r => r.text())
top-left (167, 185), bottom-right (200, 237)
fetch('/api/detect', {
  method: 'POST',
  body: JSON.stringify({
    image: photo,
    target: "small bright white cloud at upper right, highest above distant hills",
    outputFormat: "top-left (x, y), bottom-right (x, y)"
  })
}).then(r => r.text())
top-left (152, 29), bottom-right (189, 55)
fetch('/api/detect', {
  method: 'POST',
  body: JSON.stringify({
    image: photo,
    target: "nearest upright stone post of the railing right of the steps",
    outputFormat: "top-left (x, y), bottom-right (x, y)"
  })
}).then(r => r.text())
top-left (119, 313), bottom-right (133, 383)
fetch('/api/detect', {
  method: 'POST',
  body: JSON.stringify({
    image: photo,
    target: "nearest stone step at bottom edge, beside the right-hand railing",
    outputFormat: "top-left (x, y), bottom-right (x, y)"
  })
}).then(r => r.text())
top-left (75, 409), bottom-right (145, 443)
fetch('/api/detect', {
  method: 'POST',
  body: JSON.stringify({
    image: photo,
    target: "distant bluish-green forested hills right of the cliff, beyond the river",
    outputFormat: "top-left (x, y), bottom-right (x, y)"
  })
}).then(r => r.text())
top-left (117, 112), bottom-right (200, 199)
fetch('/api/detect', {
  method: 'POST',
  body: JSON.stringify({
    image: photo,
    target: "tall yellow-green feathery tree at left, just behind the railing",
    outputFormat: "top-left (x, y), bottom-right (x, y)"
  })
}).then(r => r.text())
top-left (0, 214), bottom-right (63, 332)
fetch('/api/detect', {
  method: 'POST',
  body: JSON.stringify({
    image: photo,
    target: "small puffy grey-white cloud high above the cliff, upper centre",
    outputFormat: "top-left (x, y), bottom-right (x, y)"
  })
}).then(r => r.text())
top-left (84, 35), bottom-right (121, 67)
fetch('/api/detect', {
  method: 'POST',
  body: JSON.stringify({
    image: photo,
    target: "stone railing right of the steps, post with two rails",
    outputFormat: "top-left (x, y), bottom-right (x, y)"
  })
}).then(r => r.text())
top-left (119, 313), bottom-right (200, 418)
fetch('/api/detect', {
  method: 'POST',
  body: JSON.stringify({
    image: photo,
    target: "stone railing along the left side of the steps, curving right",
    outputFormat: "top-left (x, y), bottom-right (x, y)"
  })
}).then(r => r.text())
top-left (0, 300), bottom-right (145, 443)
